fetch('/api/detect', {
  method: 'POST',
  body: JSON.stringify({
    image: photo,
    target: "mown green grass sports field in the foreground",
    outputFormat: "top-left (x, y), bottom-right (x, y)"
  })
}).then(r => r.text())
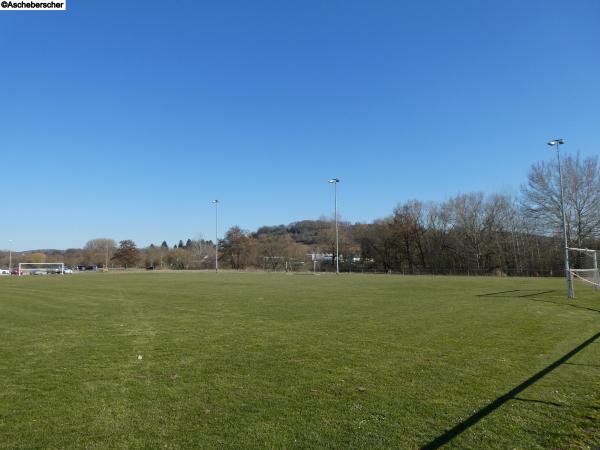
top-left (0, 273), bottom-right (600, 449)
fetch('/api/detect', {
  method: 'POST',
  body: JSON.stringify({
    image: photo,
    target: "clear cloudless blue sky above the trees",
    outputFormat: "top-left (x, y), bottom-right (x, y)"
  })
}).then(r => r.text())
top-left (0, 0), bottom-right (600, 250)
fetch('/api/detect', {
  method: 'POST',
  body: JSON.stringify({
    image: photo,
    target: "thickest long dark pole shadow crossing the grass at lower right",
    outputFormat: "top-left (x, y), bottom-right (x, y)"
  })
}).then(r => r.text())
top-left (421, 332), bottom-right (600, 450)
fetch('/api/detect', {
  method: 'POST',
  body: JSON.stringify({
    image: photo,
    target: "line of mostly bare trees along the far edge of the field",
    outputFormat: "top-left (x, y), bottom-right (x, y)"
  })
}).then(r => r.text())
top-left (0, 154), bottom-right (600, 276)
